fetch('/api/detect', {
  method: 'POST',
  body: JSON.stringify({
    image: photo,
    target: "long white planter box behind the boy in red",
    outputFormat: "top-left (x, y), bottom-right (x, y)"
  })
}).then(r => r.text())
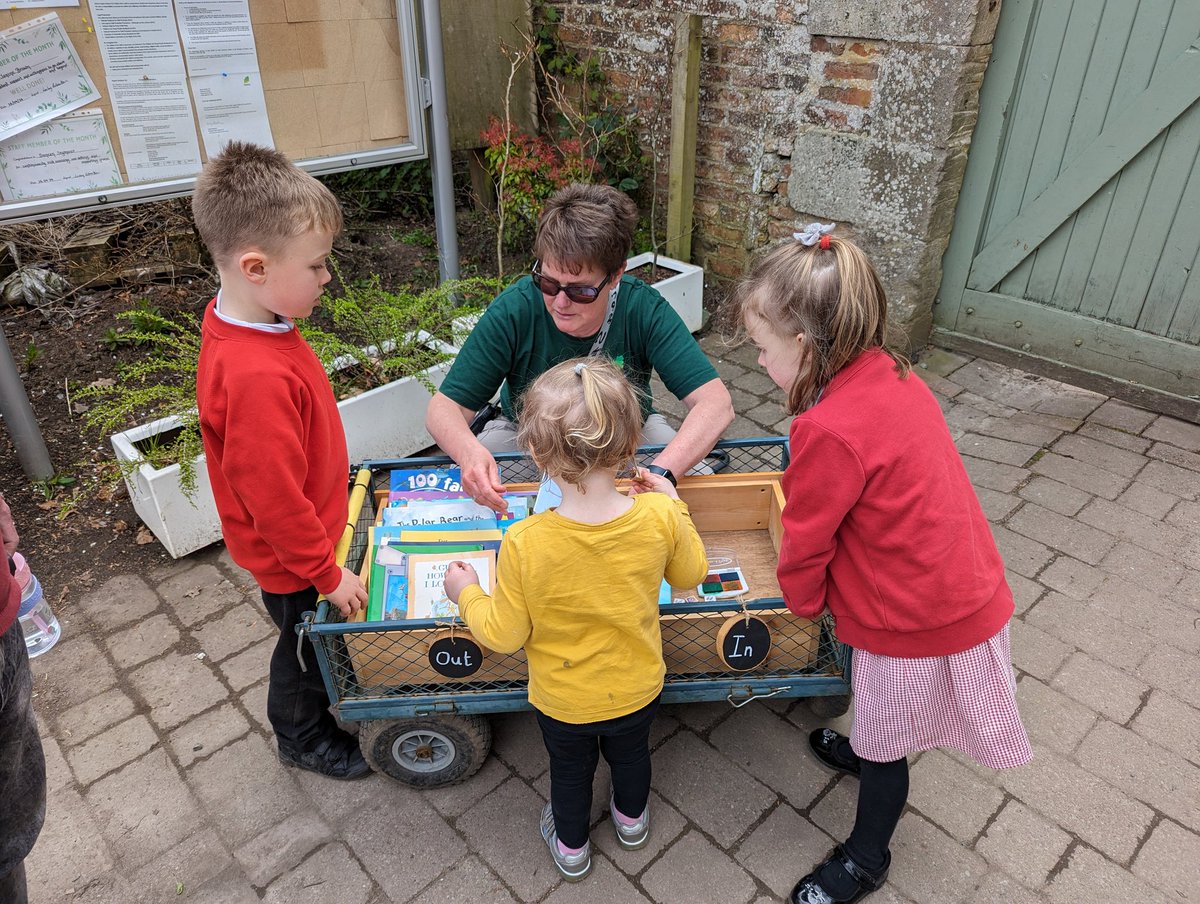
top-left (112, 343), bottom-right (455, 558)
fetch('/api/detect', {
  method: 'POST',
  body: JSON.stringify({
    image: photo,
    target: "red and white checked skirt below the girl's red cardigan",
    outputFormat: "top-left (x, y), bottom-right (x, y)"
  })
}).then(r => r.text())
top-left (850, 624), bottom-right (1033, 770)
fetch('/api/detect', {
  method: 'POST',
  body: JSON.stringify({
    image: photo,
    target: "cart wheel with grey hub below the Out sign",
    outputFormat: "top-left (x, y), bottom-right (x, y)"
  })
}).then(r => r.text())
top-left (359, 716), bottom-right (492, 788)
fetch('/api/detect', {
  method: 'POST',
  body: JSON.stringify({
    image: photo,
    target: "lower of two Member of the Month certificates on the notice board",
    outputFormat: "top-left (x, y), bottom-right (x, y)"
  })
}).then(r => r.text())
top-left (0, 110), bottom-right (121, 200)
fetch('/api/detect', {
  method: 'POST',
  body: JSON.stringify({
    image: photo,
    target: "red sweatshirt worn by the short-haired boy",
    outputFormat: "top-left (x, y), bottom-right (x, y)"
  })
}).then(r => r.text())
top-left (196, 300), bottom-right (349, 593)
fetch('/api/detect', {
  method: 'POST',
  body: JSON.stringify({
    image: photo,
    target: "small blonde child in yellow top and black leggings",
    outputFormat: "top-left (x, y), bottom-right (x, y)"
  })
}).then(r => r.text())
top-left (445, 358), bottom-right (708, 881)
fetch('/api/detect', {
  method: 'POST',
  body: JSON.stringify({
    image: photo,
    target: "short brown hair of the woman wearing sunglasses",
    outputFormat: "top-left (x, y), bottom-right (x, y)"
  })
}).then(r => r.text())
top-left (533, 182), bottom-right (637, 274)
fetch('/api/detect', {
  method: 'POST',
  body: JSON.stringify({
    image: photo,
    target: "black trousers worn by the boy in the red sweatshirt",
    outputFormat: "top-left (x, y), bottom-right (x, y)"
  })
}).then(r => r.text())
top-left (263, 587), bottom-right (337, 752)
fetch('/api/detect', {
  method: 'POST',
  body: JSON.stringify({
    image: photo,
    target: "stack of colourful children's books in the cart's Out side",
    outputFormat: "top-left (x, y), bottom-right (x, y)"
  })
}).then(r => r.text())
top-left (366, 468), bottom-right (533, 622)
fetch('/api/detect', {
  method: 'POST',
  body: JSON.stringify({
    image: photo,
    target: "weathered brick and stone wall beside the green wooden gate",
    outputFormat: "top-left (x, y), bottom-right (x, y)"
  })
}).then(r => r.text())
top-left (547, 0), bottom-right (1000, 345)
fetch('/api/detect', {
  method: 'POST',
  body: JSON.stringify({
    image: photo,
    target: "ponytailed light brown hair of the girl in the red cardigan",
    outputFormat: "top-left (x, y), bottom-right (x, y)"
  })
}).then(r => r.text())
top-left (733, 235), bottom-right (910, 414)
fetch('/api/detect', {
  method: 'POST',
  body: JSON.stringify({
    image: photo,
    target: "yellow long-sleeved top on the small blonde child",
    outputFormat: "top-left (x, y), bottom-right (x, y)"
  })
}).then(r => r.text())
top-left (458, 492), bottom-right (708, 724)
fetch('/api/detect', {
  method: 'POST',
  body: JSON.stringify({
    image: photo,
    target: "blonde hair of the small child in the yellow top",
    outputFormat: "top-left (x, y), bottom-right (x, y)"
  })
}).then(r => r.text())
top-left (517, 358), bottom-right (642, 484)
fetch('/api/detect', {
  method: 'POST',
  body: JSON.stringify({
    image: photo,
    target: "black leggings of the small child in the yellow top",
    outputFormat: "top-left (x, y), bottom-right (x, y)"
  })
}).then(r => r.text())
top-left (538, 699), bottom-right (659, 848)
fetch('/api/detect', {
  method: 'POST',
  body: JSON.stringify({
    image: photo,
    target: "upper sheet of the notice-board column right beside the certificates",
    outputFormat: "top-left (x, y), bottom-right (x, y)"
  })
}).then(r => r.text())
top-left (91, 0), bottom-right (184, 75)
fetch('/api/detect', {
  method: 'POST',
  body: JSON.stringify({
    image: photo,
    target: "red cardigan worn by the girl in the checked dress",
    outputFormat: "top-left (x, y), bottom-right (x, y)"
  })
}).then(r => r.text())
top-left (779, 348), bottom-right (1013, 657)
